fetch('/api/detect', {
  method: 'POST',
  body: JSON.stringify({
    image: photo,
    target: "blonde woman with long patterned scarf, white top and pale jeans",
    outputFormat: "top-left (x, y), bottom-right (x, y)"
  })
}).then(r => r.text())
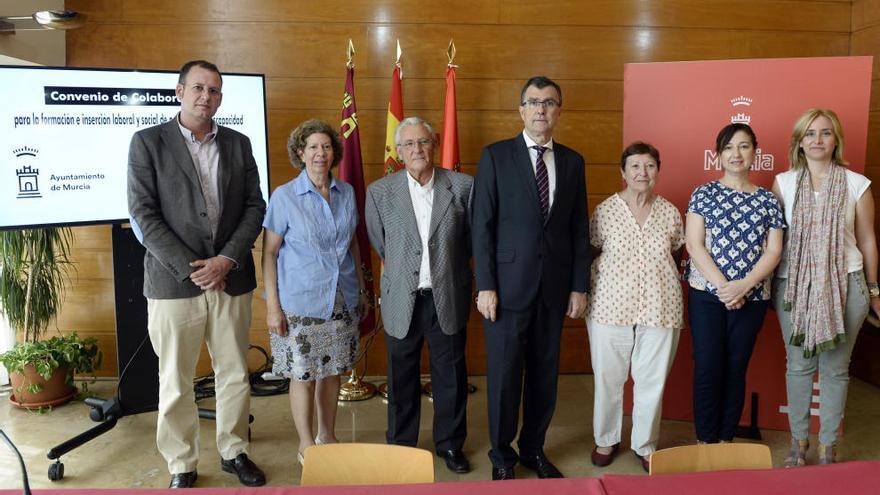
top-left (773, 108), bottom-right (880, 467)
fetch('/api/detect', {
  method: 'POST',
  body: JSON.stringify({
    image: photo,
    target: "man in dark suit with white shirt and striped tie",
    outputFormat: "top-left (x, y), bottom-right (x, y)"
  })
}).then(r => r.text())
top-left (472, 77), bottom-right (590, 480)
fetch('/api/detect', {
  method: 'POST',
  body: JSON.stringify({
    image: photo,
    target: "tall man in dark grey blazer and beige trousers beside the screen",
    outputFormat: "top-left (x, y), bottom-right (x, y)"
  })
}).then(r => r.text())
top-left (128, 60), bottom-right (266, 488)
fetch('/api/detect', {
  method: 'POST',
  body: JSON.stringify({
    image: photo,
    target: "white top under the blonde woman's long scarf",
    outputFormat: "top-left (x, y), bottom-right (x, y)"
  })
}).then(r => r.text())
top-left (776, 168), bottom-right (871, 278)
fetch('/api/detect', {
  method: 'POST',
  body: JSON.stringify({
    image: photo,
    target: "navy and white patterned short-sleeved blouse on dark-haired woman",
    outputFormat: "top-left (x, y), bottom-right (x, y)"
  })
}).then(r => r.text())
top-left (685, 180), bottom-right (785, 301)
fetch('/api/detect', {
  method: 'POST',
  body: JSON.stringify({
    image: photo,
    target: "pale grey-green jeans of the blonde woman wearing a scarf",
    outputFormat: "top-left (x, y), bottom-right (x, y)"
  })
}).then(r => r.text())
top-left (773, 271), bottom-right (870, 445)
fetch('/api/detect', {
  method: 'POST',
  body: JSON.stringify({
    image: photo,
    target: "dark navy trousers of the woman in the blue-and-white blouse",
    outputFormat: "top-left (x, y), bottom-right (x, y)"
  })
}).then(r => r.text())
top-left (688, 288), bottom-right (770, 443)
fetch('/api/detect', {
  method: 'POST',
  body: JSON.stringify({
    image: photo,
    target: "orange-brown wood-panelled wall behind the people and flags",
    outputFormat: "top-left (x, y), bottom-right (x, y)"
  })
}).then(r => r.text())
top-left (58, 0), bottom-right (860, 375)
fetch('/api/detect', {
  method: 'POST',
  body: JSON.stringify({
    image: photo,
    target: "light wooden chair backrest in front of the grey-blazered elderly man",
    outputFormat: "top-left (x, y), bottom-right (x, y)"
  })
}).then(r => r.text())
top-left (300, 443), bottom-right (434, 486)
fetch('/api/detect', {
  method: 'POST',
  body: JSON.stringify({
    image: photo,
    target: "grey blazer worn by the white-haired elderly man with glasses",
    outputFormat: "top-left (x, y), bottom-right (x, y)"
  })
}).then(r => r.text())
top-left (364, 167), bottom-right (473, 339)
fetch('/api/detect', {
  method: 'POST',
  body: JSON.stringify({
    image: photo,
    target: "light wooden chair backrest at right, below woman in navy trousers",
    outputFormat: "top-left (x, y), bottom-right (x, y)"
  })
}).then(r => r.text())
top-left (650, 443), bottom-right (773, 475)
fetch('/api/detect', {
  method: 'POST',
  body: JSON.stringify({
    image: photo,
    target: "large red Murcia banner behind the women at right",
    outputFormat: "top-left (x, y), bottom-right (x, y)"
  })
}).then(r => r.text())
top-left (621, 57), bottom-right (872, 430)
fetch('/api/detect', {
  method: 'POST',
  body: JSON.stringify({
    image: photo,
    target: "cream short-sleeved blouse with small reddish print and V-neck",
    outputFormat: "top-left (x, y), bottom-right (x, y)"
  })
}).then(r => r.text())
top-left (587, 194), bottom-right (684, 329)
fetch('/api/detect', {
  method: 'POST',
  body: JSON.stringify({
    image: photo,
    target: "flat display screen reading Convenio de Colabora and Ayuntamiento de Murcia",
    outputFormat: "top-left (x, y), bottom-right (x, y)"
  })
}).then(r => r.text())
top-left (0, 66), bottom-right (269, 229)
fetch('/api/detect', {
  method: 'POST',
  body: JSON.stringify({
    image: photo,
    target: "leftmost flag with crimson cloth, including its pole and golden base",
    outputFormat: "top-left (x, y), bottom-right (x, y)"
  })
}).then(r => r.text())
top-left (337, 39), bottom-right (382, 402)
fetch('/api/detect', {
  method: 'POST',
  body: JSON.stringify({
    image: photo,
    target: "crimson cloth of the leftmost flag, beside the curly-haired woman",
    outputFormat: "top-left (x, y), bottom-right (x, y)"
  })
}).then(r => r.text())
top-left (339, 58), bottom-right (376, 337)
